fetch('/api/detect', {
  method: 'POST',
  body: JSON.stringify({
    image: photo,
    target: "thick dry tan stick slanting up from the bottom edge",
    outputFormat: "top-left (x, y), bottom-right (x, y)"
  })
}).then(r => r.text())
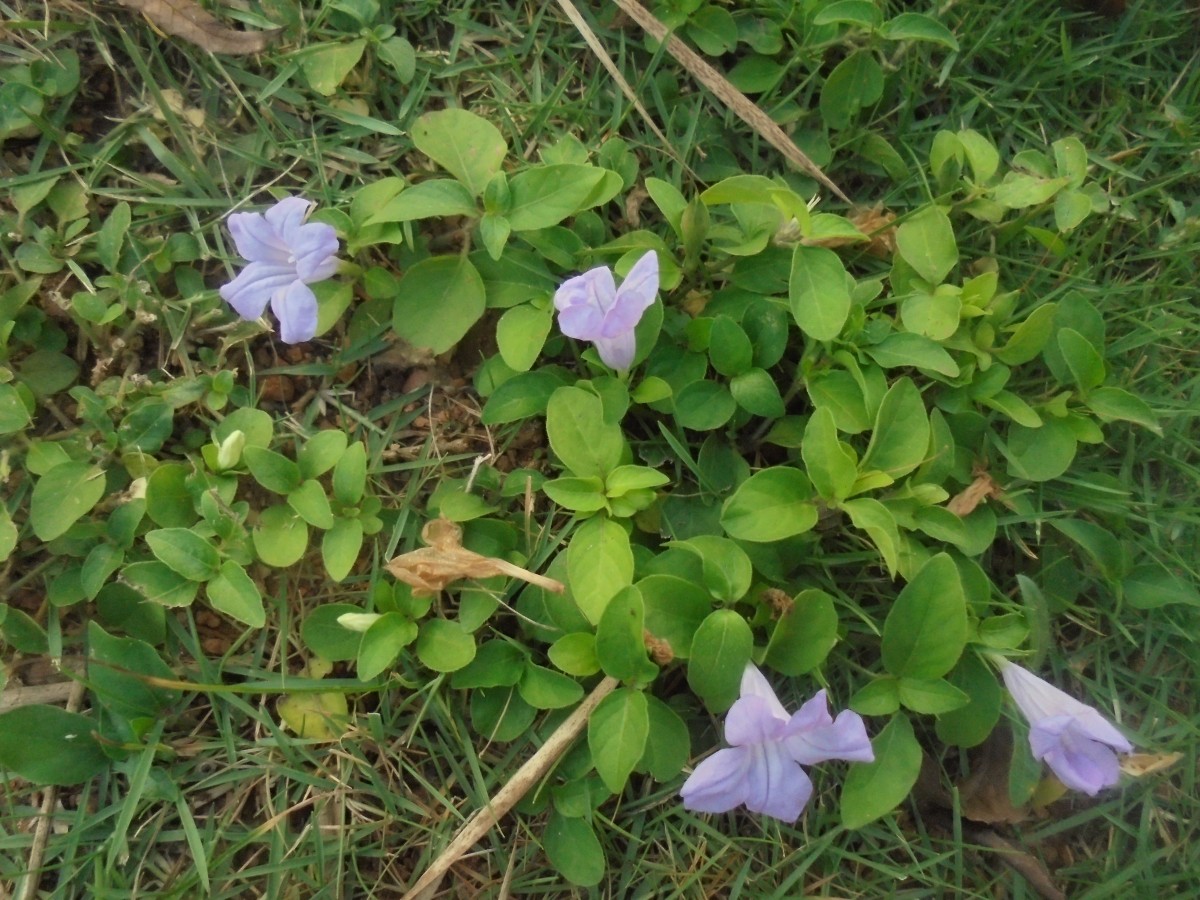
top-left (402, 678), bottom-right (617, 900)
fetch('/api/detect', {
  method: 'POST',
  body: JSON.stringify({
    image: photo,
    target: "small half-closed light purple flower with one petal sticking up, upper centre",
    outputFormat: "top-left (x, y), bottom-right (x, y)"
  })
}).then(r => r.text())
top-left (554, 250), bottom-right (659, 370)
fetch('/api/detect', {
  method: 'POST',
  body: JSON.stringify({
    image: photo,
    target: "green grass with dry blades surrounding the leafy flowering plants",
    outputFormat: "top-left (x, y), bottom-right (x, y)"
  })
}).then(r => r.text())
top-left (0, 0), bottom-right (1200, 899)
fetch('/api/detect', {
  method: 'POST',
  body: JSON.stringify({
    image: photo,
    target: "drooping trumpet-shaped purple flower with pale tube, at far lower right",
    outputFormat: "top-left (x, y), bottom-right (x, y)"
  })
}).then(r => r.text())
top-left (1000, 660), bottom-right (1133, 797)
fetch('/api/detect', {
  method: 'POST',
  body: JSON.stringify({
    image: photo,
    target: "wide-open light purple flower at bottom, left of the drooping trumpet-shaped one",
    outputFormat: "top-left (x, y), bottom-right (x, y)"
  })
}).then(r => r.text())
top-left (679, 664), bottom-right (875, 822)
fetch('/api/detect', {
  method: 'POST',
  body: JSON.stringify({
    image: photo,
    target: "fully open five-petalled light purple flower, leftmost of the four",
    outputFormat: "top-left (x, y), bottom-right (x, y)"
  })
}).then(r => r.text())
top-left (221, 197), bottom-right (338, 343)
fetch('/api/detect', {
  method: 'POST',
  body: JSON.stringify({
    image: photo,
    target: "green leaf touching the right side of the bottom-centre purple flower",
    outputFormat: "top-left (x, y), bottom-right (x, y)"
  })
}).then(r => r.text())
top-left (841, 713), bottom-right (920, 829)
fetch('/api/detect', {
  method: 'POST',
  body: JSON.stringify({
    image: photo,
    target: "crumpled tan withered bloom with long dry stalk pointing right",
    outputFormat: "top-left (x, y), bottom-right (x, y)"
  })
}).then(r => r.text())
top-left (385, 518), bottom-right (564, 596)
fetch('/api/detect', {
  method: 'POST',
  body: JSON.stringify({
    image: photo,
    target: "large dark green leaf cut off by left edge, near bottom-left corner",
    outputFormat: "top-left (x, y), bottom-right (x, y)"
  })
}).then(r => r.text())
top-left (0, 704), bottom-right (109, 785)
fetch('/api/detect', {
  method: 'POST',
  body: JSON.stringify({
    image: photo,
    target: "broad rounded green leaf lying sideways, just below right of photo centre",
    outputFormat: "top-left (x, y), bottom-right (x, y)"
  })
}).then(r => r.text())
top-left (721, 465), bottom-right (820, 542)
